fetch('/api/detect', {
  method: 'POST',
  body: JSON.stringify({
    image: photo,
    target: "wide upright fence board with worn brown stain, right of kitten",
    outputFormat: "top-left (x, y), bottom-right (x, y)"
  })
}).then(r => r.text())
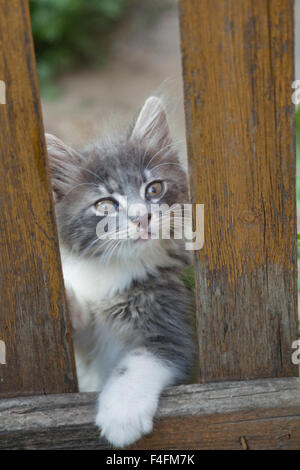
top-left (180, 0), bottom-right (298, 381)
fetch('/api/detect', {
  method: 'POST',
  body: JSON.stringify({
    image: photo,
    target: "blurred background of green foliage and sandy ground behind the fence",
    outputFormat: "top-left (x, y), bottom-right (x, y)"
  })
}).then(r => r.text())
top-left (29, 0), bottom-right (300, 306)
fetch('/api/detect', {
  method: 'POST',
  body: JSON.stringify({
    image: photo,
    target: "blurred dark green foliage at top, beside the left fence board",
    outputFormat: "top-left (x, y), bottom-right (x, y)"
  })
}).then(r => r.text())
top-left (29, 0), bottom-right (129, 91)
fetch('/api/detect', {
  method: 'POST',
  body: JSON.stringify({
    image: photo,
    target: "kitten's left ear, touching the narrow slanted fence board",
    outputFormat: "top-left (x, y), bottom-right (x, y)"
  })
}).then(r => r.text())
top-left (45, 134), bottom-right (81, 200)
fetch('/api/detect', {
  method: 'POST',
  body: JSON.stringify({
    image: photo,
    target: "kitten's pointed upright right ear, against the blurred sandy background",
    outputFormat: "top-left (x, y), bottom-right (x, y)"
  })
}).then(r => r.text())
top-left (131, 96), bottom-right (172, 147)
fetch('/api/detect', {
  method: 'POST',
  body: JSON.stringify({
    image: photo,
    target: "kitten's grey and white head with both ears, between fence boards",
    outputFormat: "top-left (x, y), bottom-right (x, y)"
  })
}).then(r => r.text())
top-left (46, 97), bottom-right (187, 259)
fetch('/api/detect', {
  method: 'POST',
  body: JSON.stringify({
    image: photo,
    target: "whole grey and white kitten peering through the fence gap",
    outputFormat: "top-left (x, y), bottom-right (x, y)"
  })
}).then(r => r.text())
top-left (47, 97), bottom-right (195, 447)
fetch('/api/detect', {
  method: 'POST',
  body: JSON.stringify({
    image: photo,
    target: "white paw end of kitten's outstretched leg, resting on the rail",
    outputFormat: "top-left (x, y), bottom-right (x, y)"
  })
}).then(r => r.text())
top-left (96, 381), bottom-right (158, 447)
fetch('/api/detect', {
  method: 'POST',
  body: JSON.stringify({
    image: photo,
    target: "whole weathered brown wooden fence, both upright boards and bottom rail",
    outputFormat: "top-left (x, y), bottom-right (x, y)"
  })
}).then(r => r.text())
top-left (0, 0), bottom-right (300, 449)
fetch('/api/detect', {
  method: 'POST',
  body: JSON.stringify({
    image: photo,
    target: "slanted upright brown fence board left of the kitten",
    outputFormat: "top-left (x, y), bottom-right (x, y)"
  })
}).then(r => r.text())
top-left (0, 0), bottom-right (77, 397)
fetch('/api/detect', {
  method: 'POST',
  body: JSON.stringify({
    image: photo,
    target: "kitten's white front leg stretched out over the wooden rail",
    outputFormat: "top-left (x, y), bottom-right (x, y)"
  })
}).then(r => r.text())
top-left (96, 349), bottom-right (176, 447)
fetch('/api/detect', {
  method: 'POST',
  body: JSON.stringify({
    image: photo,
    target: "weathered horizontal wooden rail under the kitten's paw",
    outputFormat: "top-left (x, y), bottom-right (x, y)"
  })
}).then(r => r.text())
top-left (0, 378), bottom-right (300, 449)
